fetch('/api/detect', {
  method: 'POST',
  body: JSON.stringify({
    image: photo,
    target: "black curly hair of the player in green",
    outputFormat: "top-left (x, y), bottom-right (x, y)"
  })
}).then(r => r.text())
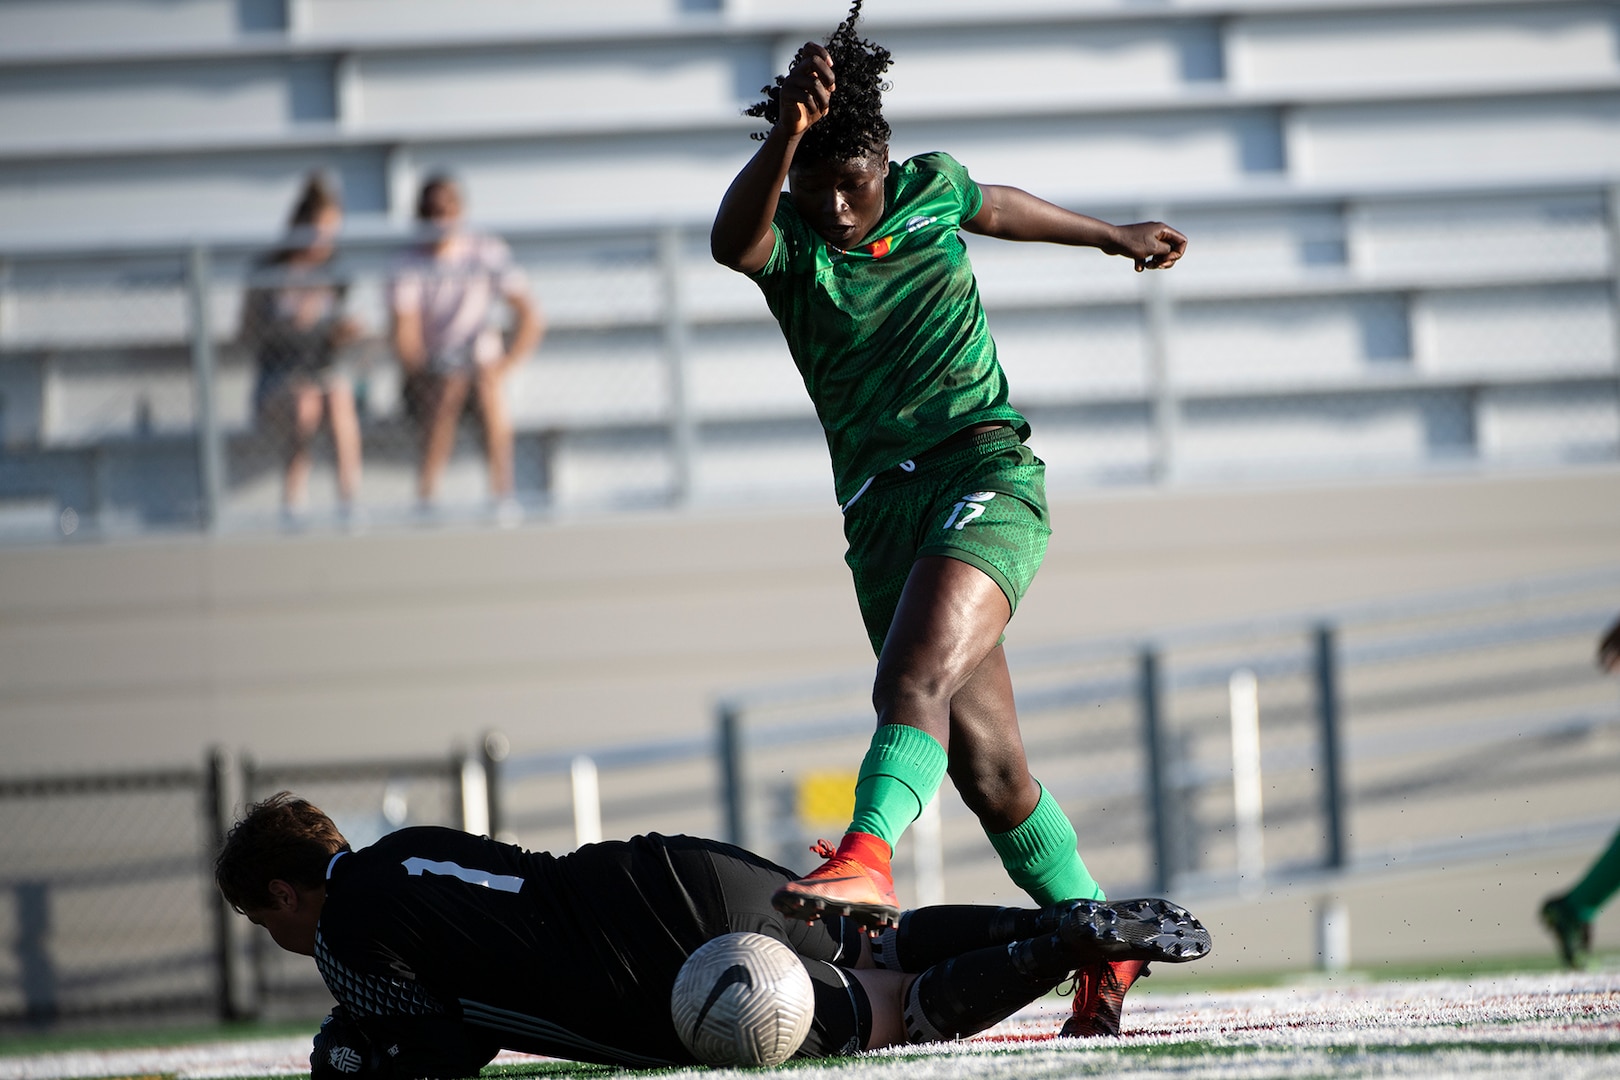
top-left (744, 0), bottom-right (893, 162)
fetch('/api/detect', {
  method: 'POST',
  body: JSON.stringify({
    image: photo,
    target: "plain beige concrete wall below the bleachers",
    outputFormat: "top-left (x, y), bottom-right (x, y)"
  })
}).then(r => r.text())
top-left (0, 468), bottom-right (1620, 776)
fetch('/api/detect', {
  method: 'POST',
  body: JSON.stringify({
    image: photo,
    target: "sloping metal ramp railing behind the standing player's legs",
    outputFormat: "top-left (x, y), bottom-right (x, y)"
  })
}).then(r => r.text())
top-left (499, 570), bottom-right (1620, 899)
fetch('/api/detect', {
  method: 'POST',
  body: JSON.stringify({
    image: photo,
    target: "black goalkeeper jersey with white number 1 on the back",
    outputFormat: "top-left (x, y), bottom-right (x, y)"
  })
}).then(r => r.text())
top-left (316, 827), bottom-right (735, 1075)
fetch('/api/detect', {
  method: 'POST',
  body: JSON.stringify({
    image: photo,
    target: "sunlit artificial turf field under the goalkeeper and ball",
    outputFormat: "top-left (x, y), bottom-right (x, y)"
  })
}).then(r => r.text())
top-left (0, 960), bottom-right (1620, 1080)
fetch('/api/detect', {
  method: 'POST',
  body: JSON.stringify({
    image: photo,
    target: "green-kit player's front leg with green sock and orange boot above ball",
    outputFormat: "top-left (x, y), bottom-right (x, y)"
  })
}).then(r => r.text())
top-left (773, 555), bottom-right (1009, 926)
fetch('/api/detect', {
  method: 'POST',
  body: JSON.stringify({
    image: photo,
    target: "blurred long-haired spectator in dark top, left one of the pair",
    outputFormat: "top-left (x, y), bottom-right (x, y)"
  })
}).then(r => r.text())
top-left (241, 175), bottom-right (360, 521)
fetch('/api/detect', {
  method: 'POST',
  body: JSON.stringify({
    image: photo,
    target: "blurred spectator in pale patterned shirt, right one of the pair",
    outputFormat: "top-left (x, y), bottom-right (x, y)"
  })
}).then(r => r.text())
top-left (390, 175), bottom-right (546, 521)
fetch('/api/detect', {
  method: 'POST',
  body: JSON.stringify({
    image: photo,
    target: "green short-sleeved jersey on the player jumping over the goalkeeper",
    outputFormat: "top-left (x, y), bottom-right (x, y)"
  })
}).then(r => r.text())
top-left (750, 154), bottom-right (1027, 504)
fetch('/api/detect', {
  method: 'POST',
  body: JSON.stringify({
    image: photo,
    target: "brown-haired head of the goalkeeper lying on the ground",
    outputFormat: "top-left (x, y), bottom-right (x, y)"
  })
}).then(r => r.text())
top-left (214, 792), bottom-right (348, 912)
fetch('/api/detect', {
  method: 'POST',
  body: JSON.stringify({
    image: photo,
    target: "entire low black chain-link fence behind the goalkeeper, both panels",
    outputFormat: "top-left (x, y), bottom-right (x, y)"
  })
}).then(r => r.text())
top-left (0, 753), bottom-right (491, 1031)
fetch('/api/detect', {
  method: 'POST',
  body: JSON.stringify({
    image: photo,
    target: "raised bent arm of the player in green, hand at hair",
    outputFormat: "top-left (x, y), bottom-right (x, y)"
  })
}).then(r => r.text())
top-left (710, 42), bottom-right (834, 274)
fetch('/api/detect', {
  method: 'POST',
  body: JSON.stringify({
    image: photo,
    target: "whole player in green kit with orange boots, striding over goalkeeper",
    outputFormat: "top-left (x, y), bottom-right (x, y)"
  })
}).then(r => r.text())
top-left (710, 0), bottom-right (1187, 1035)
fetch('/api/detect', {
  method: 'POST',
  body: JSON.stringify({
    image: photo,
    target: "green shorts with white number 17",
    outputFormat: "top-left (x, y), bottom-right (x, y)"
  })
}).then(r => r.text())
top-left (844, 427), bottom-right (1051, 654)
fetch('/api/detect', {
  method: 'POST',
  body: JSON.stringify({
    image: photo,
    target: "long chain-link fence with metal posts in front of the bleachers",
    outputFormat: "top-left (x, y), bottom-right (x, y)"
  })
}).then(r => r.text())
top-left (0, 186), bottom-right (1620, 539)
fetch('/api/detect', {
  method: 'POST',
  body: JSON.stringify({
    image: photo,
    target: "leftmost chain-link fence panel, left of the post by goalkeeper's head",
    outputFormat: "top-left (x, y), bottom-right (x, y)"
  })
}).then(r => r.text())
top-left (0, 769), bottom-right (225, 1027)
